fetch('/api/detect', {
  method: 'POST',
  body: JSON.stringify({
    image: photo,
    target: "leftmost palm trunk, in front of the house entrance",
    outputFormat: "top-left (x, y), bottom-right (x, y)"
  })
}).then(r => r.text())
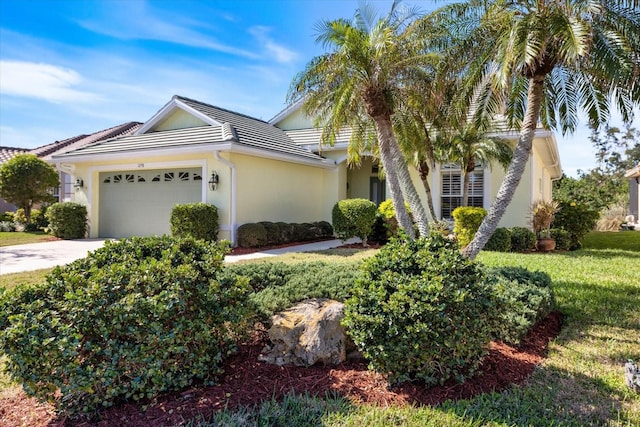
top-left (374, 116), bottom-right (415, 239)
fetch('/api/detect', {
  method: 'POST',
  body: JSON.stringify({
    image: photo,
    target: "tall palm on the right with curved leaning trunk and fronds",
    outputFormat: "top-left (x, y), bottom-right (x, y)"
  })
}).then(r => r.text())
top-left (426, 0), bottom-right (640, 258)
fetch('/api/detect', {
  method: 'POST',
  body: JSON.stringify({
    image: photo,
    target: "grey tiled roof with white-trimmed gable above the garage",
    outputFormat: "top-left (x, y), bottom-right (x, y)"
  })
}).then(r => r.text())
top-left (53, 95), bottom-right (334, 166)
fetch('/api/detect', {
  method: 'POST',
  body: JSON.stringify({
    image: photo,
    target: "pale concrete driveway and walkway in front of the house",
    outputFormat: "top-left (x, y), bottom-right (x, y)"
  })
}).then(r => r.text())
top-left (0, 239), bottom-right (358, 278)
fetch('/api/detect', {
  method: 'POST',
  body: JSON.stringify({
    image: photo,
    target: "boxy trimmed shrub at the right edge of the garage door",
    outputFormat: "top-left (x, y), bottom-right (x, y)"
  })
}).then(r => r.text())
top-left (170, 203), bottom-right (219, 241)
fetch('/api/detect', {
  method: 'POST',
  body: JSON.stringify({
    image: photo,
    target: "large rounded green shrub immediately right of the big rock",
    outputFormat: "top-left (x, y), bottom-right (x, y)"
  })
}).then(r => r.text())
top-left (344, 236), bottom-right (497, 385)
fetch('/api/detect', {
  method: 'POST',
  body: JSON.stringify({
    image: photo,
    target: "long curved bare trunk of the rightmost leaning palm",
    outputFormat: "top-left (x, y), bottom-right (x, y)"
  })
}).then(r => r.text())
top-left (462, 76), bottom-right (544, 259)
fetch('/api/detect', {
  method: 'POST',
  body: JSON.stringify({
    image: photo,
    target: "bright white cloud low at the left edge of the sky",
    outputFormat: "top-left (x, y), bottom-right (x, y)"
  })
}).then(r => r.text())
top-left (0, 60), bottom-right (99, 103)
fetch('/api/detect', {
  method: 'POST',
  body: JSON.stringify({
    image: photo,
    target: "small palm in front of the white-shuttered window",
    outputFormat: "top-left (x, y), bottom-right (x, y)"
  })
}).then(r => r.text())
top-left (437, 124), bottom-right (513, 206)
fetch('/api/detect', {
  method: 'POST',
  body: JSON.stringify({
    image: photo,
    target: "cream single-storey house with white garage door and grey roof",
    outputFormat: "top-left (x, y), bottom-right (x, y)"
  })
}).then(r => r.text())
top-left (51, 95), bottom-right (562, 243)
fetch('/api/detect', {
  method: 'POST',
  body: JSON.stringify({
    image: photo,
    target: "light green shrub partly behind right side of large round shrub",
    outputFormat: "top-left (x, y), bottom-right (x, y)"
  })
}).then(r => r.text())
top-left (487, 267), bottom-right (555, 345)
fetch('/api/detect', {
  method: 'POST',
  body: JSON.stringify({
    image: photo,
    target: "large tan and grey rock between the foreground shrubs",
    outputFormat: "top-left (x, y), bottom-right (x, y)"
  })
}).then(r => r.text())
top-left (260, 299), bottom-right (349, 366)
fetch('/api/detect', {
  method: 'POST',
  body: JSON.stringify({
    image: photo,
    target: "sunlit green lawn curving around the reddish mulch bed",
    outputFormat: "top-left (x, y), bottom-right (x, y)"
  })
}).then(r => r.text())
top-left (0, 232), bottom-right (640, 427)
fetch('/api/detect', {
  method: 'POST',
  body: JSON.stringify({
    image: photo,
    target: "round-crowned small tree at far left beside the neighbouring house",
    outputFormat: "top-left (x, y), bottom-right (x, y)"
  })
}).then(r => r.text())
top-left (0, 154), bottom-right (60, 222)
